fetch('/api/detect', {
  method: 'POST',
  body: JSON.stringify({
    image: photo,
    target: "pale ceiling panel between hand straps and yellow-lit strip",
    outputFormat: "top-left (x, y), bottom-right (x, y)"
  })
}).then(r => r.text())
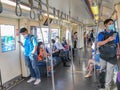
top-left (42, 0), bottom-right (93, 23)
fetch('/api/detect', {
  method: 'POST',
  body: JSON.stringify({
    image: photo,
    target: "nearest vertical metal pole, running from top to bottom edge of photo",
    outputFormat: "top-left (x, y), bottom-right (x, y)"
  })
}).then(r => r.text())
top-left (46, 0), bottom-right (55, 90)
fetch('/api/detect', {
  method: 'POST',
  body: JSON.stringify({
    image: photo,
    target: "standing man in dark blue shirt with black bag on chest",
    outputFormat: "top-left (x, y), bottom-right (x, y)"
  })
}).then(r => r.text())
top-left (97, 19), bottom-right (119, 90)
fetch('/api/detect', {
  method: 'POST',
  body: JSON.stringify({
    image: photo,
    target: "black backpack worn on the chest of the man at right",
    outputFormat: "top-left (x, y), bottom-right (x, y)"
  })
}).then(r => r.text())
top-left (99, 32), bottom-right (117, 60)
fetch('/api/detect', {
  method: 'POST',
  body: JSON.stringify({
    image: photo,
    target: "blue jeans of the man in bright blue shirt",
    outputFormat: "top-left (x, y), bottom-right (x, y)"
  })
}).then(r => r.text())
top-left (25, 55), bottom-right (40, 79)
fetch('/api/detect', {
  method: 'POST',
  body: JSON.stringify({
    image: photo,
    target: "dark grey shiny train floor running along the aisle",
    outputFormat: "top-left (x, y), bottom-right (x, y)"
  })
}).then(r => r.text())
top-left (10, 50), bottom-right (97, 90)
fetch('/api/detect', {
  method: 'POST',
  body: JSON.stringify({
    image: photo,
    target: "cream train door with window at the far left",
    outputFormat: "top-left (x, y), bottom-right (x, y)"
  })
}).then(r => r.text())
top-left (0, 17), bottom-right (21, 83)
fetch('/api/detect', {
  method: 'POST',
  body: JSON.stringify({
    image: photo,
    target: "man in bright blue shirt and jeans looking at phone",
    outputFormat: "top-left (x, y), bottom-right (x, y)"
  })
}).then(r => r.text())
top-left (19, 28), bottom-right (41, 85)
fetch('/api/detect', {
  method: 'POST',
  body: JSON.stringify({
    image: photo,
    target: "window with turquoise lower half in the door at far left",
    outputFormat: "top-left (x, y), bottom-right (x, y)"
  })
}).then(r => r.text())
top-left (0, 25), bottom-right (16, 52)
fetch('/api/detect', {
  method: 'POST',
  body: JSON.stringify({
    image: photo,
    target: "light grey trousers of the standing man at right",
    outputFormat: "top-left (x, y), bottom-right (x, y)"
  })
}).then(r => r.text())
top-left (100, 58), bottom-right (115, 90)
